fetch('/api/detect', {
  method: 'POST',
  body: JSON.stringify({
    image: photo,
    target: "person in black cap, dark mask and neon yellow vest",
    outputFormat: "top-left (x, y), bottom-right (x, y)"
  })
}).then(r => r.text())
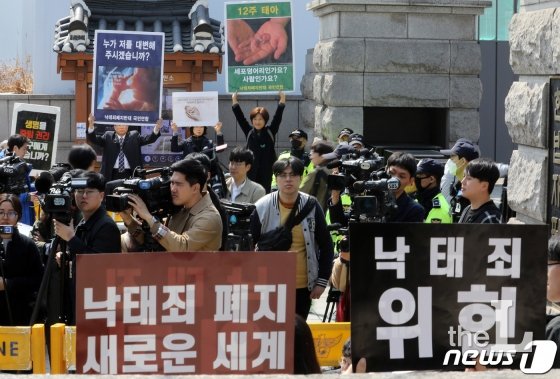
top-left (414, 158), bottom-right (452, 224)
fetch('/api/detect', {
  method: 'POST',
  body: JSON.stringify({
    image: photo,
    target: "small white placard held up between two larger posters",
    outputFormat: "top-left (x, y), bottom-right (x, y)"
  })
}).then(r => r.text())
top-left (172, 91), bottom-right (219, 126)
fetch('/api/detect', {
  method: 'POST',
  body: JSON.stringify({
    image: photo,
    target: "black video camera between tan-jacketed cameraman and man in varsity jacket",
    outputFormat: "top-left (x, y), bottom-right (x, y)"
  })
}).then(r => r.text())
top-left (220, 199), bottom-right (255, 251)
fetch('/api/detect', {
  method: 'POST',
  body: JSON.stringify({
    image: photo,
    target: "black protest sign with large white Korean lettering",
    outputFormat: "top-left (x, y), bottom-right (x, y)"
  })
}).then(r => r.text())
top-left (350, 224), bottom-right (547, 371)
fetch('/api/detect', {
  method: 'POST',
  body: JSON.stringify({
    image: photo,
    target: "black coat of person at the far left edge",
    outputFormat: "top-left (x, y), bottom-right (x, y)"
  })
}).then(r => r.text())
top-left (0, 230), bottom-right (43, 326)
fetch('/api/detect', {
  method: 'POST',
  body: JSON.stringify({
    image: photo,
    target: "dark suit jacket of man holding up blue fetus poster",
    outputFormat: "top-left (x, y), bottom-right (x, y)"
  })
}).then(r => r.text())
top-left (87, 130), bottom-right (160, 181)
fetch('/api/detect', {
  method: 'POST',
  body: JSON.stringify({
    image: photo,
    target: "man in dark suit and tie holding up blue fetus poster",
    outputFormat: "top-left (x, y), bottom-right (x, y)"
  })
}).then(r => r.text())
top-left (87, 115), bottom-right (162, 181)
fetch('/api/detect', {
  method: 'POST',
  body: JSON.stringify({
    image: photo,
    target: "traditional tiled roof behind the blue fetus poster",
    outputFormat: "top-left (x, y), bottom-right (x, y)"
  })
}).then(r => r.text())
top-left (53, 0), bottom-right (223, 54)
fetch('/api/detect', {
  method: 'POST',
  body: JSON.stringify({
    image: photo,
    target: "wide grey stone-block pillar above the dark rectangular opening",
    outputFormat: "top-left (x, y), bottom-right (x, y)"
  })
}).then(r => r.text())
top-left (301, 0), bottom-right (491, 143)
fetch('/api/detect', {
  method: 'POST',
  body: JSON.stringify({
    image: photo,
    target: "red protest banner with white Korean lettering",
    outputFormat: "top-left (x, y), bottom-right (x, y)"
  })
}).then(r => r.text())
top-left (76, 253), bottom-right (295, 374)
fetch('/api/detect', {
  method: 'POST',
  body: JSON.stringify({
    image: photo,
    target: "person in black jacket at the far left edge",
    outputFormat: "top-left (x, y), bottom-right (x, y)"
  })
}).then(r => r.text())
top-left (0, 194), bottom-right (43, 326)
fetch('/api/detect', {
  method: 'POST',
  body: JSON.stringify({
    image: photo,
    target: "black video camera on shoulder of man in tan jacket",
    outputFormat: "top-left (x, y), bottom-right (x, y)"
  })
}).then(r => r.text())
top-left (105, 167), bottom-right (174, 218)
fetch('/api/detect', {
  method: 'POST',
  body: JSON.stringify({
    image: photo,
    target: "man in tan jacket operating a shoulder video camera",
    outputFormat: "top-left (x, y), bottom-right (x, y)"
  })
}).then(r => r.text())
top-left (120, 158), bottom-right (222, 251)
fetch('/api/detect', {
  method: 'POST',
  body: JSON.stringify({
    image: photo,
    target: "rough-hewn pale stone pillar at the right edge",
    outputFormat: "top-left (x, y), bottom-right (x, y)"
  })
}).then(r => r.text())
top-left (505, 0), bottom-right (560, 224)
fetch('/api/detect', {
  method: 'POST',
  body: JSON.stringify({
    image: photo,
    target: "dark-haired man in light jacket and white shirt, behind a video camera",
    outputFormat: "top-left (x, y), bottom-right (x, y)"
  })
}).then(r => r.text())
top-left (226, 147), bottom-right (266, 204)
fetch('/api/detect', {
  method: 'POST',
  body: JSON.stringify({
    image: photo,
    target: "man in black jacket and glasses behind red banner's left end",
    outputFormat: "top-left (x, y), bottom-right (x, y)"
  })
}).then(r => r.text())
top-left (53, 172), bottom-right (121, 325)
